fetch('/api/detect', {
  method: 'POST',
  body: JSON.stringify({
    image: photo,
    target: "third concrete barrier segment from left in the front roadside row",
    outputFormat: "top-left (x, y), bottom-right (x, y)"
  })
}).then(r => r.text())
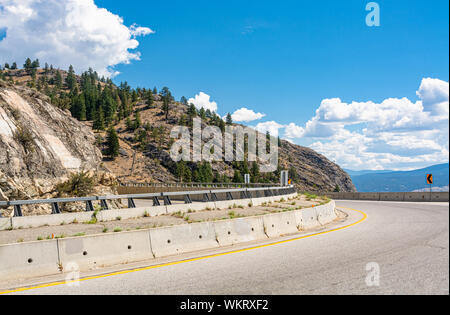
top-left (150, 222), bottom-right (219, 257)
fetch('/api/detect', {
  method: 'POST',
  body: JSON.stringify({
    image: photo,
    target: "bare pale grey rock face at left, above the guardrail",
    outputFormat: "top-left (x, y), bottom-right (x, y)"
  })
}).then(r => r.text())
top-left (0, 81), bottom-right (102, 206)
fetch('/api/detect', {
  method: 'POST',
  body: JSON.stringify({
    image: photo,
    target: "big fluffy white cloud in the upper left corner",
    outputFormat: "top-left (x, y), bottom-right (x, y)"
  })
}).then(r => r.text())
top-left (0, 0), bottom-right (154, 76)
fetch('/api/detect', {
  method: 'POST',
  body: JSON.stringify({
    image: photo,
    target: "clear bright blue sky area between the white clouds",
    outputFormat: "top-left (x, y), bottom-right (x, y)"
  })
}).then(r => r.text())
top-left (100, 0), bottom-right (449, 123)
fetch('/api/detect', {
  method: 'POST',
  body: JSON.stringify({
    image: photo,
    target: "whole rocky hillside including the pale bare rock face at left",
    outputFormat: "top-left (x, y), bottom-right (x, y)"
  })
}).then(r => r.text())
top-left (0, 69), bottom-right (355, 207)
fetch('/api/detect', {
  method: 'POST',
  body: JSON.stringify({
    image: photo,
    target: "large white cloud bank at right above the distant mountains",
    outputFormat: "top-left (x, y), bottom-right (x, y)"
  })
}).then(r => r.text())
top-left (284, 78), bottom-right (449, 170)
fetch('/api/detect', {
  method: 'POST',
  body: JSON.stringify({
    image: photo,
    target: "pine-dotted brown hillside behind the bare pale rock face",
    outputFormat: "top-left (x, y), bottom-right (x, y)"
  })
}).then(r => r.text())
top-left (0, 60), bottom-right (355, 191)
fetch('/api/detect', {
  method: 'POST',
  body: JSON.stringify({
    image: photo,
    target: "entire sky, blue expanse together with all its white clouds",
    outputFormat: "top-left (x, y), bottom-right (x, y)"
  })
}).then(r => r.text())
top-left (0, 0), bottom-right (449, 169)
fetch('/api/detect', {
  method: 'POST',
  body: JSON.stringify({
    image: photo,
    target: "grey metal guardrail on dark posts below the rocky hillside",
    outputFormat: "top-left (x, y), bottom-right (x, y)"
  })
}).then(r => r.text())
top-left (0, 185), bottom-right (295, 217)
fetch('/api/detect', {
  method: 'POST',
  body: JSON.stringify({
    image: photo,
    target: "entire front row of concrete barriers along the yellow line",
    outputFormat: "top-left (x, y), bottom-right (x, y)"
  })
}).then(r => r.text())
top-left (0, 202), bottom-right (336, 281)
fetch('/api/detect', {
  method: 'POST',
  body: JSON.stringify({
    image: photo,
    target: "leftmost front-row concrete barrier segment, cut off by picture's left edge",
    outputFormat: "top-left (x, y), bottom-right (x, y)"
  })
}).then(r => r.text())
top-left (0, 240), bottom-right (59, 281)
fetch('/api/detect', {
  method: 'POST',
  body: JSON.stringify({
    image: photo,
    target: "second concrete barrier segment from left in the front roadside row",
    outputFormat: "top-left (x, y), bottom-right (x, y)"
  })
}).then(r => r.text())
top-left (58, 230), bottom-right (154, 271)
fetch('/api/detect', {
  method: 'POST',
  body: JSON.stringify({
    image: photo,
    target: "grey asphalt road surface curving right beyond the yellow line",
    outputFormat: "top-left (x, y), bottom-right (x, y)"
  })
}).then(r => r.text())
top-left (1, 201), bottom-right (449, 295)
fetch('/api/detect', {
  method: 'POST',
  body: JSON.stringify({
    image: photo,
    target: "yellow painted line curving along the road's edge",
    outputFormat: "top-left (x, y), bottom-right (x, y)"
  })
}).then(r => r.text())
top-left (0, 207), bottom-right (368, 295)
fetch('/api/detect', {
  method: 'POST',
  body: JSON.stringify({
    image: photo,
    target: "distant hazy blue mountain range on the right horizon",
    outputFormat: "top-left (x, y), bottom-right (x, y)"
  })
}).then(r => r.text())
top-left (345, 163), bottom-right (449, 192)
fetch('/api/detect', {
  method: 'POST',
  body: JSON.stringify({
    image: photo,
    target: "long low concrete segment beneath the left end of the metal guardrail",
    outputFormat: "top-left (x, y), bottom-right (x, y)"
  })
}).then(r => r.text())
top-left (11, 212), bottom-right (93, 229)
